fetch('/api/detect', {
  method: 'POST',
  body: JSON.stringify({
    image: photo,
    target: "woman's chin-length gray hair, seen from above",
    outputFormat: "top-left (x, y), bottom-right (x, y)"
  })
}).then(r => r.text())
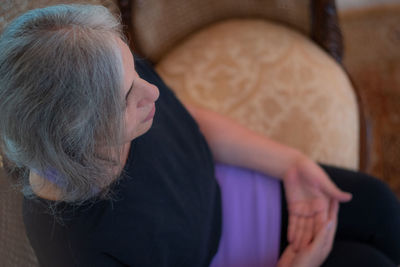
top-left (0, 5), bottom-right (125, 202)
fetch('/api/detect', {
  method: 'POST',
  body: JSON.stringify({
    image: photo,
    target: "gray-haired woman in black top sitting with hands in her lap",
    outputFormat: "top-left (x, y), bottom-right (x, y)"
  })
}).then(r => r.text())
top-left (0, 5), bottom-right (400, 266)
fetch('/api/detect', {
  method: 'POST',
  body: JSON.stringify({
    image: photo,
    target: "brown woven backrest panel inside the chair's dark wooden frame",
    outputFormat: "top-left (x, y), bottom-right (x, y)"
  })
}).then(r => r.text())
top-left (132, 0), bottom-right (311, 62)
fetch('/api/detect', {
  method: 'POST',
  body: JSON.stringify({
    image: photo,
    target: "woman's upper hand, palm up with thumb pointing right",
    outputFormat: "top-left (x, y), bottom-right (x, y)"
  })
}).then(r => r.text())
top-left (283, 155), bottom-right (352, 251)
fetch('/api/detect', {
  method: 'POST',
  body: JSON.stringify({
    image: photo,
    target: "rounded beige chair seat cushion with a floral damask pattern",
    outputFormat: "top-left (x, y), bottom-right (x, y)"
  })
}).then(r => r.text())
top-left (157, 19), bottom-right (359, 169)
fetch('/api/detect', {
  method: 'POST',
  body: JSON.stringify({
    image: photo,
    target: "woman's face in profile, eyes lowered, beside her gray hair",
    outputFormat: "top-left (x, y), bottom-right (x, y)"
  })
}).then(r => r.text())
top-left (118, 38), bottom-right (159, 143)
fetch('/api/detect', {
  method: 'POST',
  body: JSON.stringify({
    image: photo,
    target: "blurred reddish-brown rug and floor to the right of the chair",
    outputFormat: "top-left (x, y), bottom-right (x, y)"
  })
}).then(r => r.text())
top-left (336, 0), bottom-right (400, 197)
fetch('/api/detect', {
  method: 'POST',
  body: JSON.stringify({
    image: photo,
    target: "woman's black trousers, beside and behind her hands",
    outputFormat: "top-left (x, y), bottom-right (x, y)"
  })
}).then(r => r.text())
top-left (280, 164), bottom-right (400, 267)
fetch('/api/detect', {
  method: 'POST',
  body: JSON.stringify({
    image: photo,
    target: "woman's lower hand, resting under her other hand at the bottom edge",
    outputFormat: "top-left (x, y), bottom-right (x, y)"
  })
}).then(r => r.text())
top-left (277, 201), bottom-right (339, 267)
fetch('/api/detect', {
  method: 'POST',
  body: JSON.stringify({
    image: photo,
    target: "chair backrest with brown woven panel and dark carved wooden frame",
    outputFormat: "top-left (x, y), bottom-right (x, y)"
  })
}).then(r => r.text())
top-left (118, 0), bottom-right (342, 63)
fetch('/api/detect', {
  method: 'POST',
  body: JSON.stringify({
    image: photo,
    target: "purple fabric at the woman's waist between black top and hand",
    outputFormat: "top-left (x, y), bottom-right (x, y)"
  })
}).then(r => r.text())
top-left (211, 164), bottom-right (281, 267)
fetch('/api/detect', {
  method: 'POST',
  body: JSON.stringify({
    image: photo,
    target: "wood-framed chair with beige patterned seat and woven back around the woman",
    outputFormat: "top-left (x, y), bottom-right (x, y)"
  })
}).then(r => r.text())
top-left (0, 0), bottom-right (365, 266)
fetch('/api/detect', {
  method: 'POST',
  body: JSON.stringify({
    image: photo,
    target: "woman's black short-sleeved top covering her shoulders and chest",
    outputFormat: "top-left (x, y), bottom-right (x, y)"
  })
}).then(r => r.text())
top-left (24, 60), bottom-right (221, 267)
